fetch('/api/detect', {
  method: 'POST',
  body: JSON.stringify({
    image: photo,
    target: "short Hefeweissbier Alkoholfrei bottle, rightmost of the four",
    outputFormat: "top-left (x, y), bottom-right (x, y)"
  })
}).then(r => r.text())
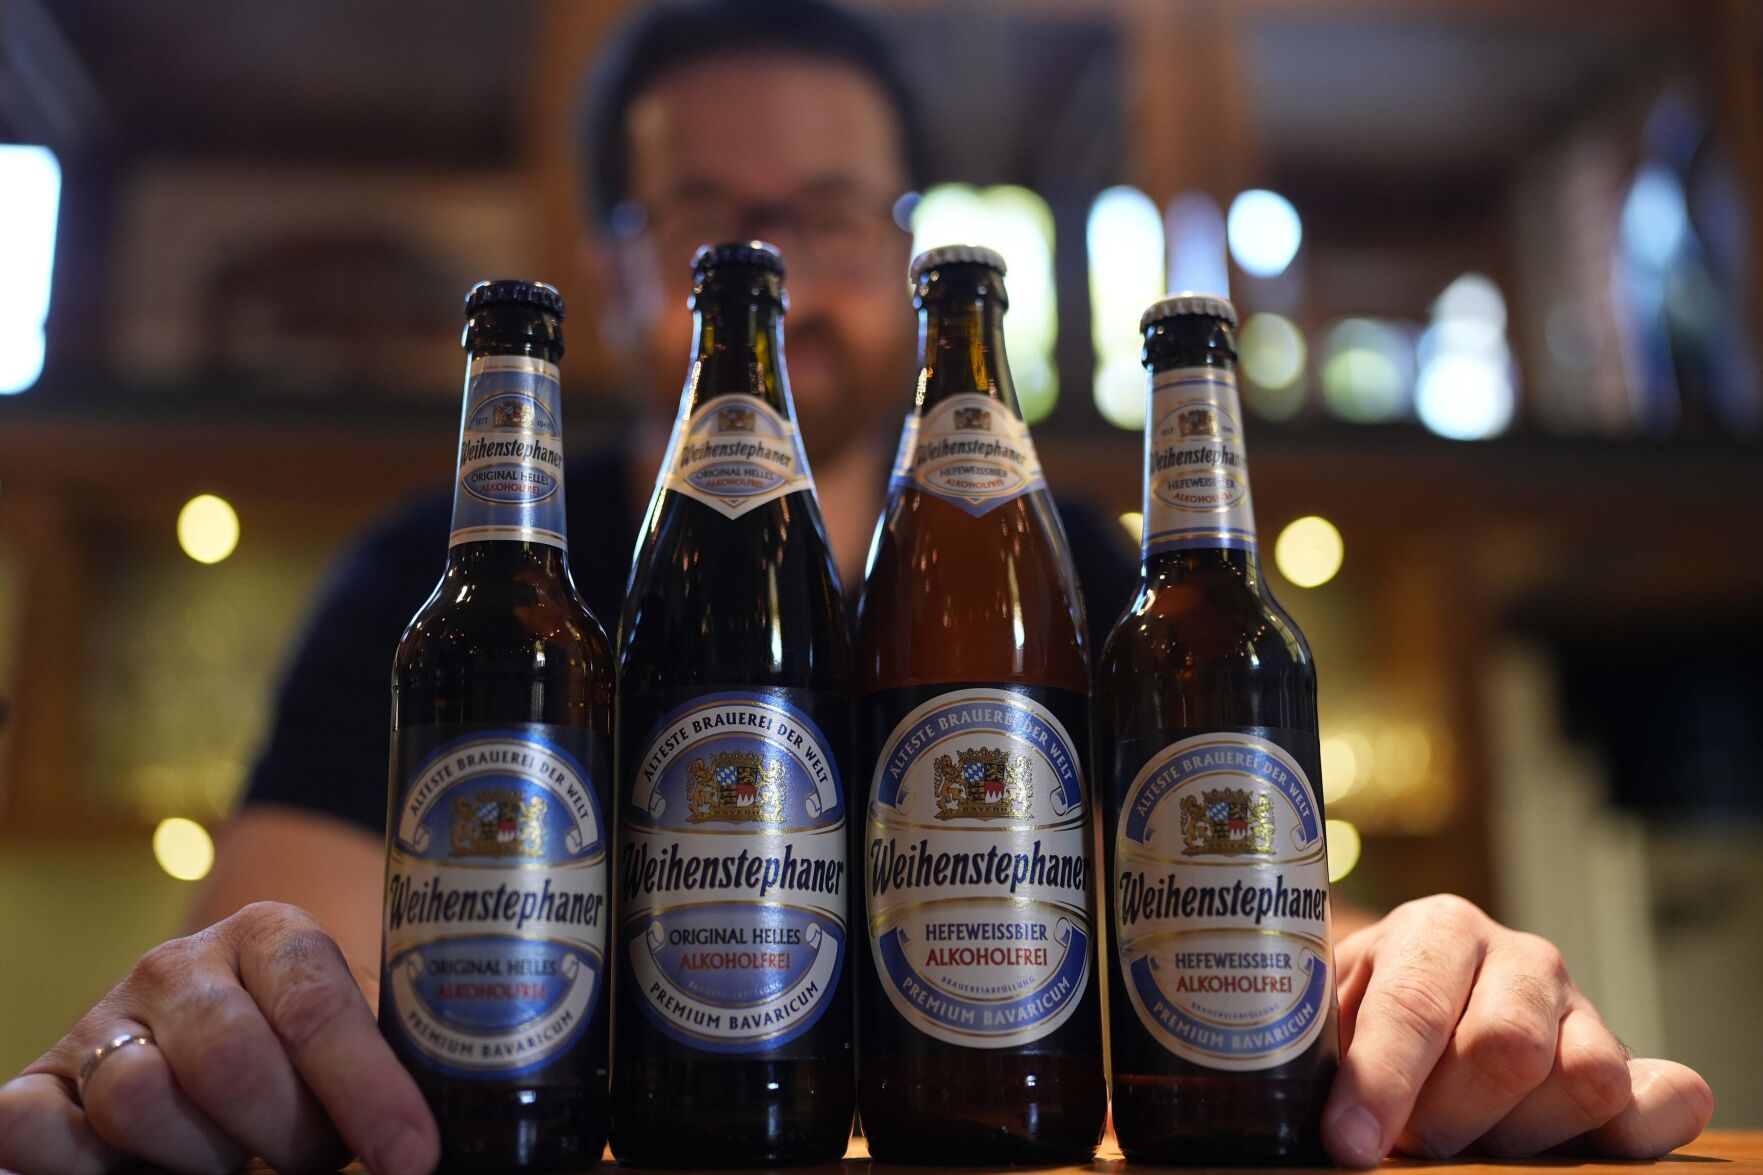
top-left (1095, 295), bottom-right (1340, 1164)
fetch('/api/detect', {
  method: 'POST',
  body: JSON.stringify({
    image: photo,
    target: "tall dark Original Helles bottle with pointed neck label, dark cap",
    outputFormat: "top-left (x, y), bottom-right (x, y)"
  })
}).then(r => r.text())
top-left (612, 242), bottom-right (853, 1166)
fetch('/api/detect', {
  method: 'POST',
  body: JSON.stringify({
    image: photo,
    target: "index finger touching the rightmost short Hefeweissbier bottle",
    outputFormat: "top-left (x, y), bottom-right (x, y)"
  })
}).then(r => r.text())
top-left (1322, 900), bottom-right (1486, 1166)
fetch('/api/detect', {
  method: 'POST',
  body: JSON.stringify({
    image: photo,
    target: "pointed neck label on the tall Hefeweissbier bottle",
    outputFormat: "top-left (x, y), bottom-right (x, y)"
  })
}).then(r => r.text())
top-left (894, 392), bottom-right (1047, 517)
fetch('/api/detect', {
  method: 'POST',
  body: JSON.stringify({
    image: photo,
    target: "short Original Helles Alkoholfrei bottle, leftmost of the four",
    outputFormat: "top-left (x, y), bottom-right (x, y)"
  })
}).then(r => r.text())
top-left (379, 281), bottom-right (612, 1171)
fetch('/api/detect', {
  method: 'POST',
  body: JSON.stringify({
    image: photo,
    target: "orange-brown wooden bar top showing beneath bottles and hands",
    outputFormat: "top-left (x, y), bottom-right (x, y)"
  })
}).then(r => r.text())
top-left (250, 1131), bottom-right (1763, 1175)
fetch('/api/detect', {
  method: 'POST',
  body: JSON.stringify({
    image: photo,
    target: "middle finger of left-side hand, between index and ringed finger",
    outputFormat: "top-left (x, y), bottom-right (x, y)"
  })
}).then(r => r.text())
top-left (146, 951), bottom-right (349, 1171)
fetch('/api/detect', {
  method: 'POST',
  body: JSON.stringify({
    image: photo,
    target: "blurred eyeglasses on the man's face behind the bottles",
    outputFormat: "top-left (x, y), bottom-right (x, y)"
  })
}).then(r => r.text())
top-left (612, 187), bottom-right (906, 281)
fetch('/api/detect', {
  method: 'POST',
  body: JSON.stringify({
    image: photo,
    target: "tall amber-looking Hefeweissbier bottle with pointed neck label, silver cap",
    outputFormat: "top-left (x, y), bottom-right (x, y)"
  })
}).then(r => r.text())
top-left (857, 245), bottom-right (1107, 1164)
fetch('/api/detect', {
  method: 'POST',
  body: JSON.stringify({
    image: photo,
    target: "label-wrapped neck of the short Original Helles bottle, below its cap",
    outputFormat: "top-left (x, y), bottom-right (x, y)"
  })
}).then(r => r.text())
top-left (448, 339), bottom-right (569, 573)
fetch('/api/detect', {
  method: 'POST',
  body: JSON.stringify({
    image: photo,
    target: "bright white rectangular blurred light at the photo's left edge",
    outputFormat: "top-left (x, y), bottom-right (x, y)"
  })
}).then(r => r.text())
top-left (0, 143), bottom-right (62, 395)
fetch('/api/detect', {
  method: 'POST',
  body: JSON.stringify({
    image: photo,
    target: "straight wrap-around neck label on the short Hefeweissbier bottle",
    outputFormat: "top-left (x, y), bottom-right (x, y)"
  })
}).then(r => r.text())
top-left (1144, 367), bottom-right (1255, 554)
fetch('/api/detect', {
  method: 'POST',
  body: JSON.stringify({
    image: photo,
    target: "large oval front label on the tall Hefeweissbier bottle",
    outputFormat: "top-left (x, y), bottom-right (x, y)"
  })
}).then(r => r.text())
top-left (864, 688), bottom-right (1091, 1048)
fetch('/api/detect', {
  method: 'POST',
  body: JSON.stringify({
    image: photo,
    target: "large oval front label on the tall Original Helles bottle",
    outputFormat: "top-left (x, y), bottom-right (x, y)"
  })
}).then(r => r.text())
top-left (621, 692), bottom-right (848, 1053)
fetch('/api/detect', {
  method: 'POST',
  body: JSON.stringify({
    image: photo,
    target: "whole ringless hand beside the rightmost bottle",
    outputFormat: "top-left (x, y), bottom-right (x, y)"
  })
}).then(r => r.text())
top-left (1322, 896), bottom-right (1714, 1166)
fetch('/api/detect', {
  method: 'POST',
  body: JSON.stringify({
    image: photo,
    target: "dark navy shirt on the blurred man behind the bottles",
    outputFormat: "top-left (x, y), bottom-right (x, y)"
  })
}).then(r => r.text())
top-left (245, 448), bottom-right (1137, 836)
